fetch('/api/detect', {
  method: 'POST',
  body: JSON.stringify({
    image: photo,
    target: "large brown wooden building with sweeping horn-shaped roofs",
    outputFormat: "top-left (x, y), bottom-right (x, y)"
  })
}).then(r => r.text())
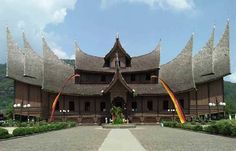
top-left (6, 23), bottom-right (230, 123)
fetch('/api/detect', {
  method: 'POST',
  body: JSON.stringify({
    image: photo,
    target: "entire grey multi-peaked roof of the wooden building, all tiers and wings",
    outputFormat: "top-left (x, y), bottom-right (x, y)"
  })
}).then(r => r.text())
top-left (6, 22), bottom-right (230, 96)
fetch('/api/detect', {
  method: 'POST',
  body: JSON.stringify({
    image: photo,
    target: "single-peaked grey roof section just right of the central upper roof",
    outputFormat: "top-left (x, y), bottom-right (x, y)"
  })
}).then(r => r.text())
top-left (159, 35), bottom-right (195, 92)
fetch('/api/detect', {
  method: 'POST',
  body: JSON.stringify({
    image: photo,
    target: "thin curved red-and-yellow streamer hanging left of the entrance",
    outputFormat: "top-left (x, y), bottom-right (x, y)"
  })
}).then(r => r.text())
top-left (49, 74), bottom-right (80, 122)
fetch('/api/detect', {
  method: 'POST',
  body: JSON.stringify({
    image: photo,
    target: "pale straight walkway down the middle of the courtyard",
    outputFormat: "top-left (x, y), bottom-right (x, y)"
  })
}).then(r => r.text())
top-left (99, 129), bottom-right (145, 151)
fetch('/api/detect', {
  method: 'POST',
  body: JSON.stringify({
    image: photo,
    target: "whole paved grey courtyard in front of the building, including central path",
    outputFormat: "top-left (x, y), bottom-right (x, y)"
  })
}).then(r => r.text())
top-left (0, 126), bottom-right (236, 151)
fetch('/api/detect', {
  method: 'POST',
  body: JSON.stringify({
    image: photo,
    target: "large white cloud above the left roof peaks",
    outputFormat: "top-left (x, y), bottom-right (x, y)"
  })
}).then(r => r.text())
top-left (0, 0), bottom-right (77, 63)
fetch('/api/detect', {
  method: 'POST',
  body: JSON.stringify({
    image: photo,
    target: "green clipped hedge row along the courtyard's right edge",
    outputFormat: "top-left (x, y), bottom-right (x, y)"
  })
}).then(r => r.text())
top-left (163, 120), bottom-right (236, 136)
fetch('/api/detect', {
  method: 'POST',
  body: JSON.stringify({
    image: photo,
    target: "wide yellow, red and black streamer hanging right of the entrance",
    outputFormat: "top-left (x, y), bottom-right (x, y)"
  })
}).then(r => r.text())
top-left (159, 79), bottom-right (186, 124)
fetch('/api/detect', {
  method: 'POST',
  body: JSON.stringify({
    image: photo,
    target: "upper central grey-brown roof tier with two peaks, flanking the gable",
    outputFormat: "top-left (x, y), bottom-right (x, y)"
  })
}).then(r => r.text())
top-left (75, 43), bottom-right (160, 73)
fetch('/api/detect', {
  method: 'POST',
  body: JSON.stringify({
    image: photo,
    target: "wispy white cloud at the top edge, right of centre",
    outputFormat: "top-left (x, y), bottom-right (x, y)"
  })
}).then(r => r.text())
top-left (101, 0), bottom-right (194, 11)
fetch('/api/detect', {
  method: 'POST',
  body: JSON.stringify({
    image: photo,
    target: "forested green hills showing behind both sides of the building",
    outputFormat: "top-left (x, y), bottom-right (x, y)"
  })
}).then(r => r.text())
top-left (0, 63), bottom-right (236, 113)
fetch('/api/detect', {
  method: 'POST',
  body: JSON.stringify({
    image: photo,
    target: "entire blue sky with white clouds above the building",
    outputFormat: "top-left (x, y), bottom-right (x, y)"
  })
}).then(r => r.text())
top-left (0, 0), bottom-right (236, 83)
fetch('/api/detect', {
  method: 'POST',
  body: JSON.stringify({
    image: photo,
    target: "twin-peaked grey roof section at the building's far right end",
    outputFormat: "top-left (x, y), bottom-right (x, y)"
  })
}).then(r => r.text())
top-left (193, 22), bottom-right (230, 84)
